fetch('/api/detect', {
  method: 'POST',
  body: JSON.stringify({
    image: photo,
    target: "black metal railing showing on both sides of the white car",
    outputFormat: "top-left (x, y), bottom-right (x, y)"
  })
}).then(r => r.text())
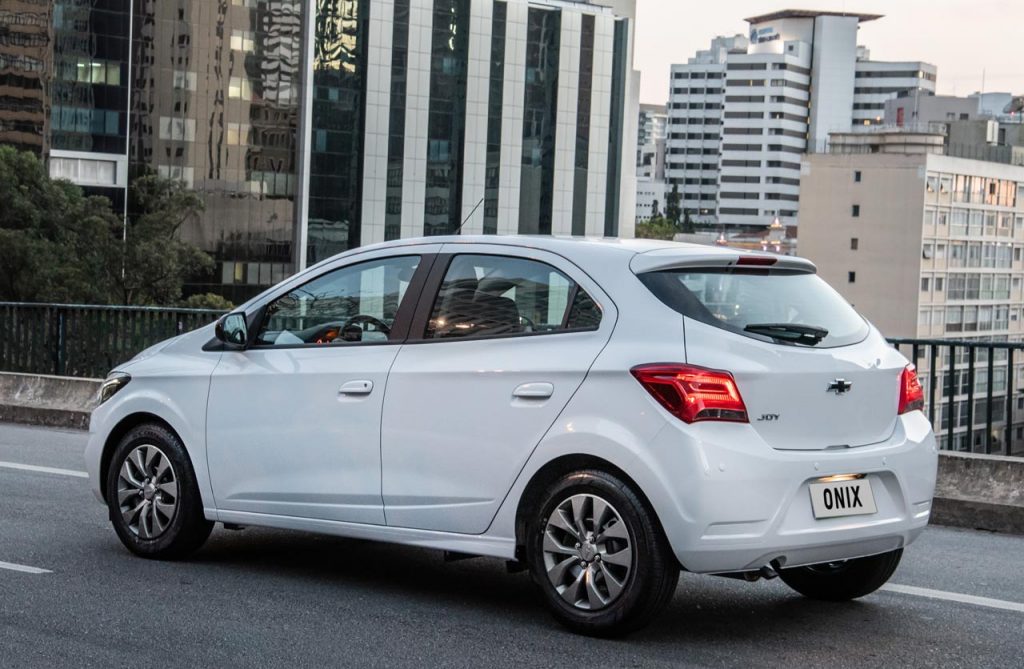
top-left (0, 302), bottom-right (1024, 456)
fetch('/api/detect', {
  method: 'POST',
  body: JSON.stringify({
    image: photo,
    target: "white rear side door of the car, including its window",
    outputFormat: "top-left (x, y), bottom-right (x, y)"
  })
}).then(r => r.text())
top-left (381, 244), bottom-right (615, 534)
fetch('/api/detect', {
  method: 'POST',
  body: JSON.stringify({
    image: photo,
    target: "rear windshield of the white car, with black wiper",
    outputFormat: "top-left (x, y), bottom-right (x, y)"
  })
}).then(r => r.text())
top-left (640, 268), bottom-right (868, 348)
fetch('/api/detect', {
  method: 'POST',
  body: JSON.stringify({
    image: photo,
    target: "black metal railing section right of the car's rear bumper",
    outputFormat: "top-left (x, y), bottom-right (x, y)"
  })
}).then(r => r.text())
top-left (889, 338), bottom-right (1024, 456)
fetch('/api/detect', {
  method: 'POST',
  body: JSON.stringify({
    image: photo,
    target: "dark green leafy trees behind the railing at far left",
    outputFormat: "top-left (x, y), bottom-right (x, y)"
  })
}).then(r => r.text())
top-left (0, 147), bottom-right (213, 304)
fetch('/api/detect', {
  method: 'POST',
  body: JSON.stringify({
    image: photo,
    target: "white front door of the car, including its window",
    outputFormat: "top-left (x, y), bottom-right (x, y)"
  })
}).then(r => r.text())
top-left (207, 245), bottom-right (440, 525)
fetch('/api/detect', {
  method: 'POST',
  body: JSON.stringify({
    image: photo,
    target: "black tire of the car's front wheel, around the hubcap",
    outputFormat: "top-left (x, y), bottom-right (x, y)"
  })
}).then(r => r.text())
top-left (105, 423), bottom-right (213, 559)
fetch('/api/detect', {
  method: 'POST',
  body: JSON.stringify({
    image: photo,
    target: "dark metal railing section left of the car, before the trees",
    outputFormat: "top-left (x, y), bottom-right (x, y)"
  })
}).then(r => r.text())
top-left (0, 302), bottom-right (222, 378)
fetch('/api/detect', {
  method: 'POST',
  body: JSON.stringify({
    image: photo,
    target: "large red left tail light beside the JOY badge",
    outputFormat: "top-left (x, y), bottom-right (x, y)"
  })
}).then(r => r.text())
top-left (630, 365), bottom-right (749, 423)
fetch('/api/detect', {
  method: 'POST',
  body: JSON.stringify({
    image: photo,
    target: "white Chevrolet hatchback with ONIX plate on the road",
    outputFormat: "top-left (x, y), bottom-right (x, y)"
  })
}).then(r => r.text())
top-left (86, 236), bottom-right (937, 635)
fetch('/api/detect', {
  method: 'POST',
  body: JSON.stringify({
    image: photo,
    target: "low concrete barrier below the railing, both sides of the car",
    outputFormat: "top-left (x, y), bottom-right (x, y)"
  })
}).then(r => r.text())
top-left (0, 373), bottom-right (1024, 534)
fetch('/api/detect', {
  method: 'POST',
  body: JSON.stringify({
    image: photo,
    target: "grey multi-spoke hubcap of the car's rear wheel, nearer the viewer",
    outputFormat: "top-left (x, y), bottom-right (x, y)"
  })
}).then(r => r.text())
top-left (543, 494), bottom-right (633, 611)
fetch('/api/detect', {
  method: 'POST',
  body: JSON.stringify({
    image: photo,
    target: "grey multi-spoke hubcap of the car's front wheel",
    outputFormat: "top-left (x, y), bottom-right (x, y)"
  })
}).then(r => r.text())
top-left (118, 444), bottom-right (178, 539)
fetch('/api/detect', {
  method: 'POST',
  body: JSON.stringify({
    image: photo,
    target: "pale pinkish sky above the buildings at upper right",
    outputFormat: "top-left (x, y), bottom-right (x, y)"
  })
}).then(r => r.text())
top-left (635, 0), bottom-right (1024, 104)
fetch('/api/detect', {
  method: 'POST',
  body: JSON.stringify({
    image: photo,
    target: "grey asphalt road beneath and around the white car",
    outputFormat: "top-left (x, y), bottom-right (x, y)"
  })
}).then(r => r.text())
top-left (0, 424), bottom-right (1024, 669)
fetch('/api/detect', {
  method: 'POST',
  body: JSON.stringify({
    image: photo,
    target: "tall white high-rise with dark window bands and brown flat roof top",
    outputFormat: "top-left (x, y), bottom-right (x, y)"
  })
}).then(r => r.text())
top-left (666, 10), bottom-right (936, 226)
